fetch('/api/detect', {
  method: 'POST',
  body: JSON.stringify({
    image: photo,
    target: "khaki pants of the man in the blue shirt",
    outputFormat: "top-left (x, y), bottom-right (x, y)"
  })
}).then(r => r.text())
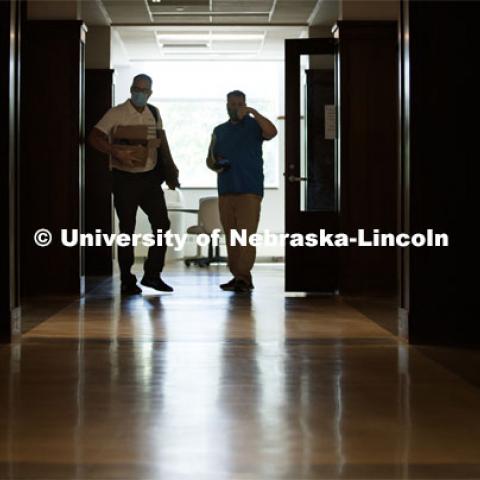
top-left (219, 193), bottom-right (262, 283)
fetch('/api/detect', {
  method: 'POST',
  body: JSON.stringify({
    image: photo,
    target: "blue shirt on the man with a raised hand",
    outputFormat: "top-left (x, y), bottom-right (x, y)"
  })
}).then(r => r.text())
top-left (213, 115), bottom-right (264, 197)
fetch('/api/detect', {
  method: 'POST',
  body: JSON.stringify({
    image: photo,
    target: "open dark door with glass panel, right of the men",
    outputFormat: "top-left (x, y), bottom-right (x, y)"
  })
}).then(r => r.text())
top-left (284, 39), bottom-right (339, 293)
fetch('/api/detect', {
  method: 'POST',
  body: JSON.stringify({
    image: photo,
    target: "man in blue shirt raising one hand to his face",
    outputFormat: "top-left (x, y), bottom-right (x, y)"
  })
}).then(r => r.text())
top-left (207, 90), bottom-right (277, 292)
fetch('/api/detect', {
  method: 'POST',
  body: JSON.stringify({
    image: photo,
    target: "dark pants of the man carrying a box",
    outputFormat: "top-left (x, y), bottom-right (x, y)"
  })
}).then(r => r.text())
top-left (112, 169), bottom-right (170, 282)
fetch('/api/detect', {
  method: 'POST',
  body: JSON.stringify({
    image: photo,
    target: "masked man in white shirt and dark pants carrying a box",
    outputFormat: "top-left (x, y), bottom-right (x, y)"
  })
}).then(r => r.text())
top-left (89, 74), bottom-right (180, 294)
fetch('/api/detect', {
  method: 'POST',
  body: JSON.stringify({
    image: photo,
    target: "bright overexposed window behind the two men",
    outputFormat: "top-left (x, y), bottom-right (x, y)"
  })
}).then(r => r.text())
top-left (145, 61), bottom-right (281, 188)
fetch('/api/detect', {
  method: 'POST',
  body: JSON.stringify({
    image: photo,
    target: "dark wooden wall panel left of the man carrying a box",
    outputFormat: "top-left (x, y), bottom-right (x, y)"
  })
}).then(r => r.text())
top-left (20, 20), bottom-right (85, 296)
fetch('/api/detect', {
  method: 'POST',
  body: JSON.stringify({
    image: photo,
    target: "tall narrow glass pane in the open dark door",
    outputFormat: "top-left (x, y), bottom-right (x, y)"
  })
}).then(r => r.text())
top-left (298, 55), bottom-right (336, 212)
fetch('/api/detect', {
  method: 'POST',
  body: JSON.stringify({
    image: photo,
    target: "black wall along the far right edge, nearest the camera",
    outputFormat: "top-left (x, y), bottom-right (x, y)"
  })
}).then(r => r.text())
top-left (402, 1), bottom-right (480, 345)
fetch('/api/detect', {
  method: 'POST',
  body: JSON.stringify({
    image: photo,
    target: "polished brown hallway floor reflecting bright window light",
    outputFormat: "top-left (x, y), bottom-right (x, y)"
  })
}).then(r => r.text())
top-left (0, 265), bottom-right (480, 480)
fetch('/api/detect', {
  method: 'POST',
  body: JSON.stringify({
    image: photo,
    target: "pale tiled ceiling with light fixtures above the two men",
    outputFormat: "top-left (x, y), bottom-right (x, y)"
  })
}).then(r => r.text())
top-left (81, 0), bottom-right (338, 66)
